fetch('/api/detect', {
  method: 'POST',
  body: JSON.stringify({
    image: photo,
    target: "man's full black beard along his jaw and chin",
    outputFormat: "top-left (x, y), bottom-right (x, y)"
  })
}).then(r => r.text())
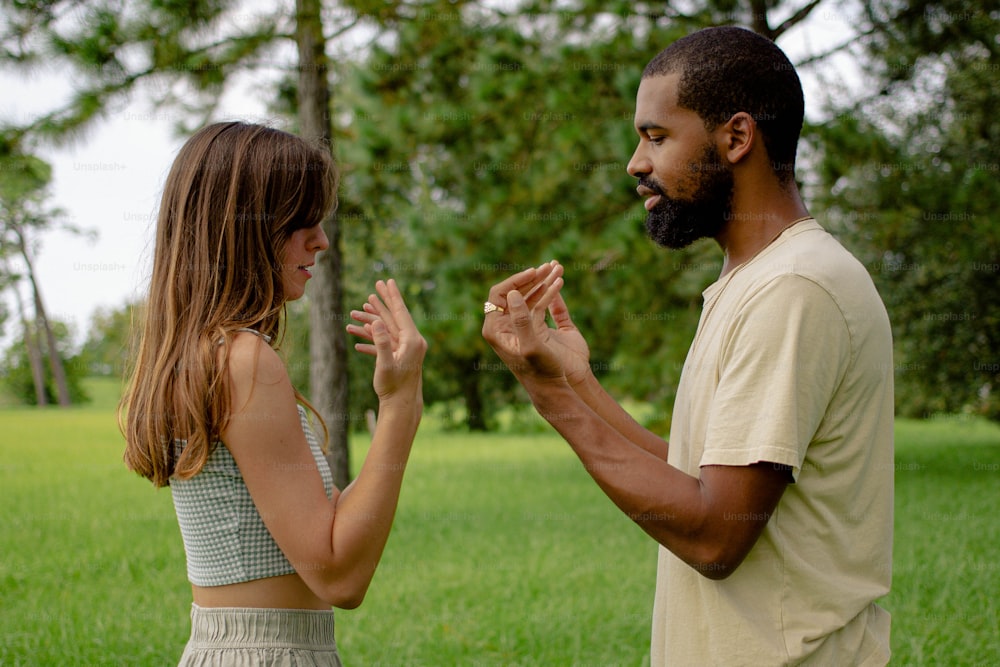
top-left (639, 144), bottom-right (733, 250)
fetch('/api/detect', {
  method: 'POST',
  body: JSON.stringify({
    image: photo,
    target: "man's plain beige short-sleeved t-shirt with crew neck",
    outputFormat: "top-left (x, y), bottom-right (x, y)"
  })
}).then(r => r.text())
top-left (651, 220), bottom-right (894, 667)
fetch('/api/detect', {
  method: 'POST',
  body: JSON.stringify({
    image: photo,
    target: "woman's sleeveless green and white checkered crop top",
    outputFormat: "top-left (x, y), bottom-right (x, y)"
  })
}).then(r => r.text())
top-left (170, 405), bottom-right (333, 586)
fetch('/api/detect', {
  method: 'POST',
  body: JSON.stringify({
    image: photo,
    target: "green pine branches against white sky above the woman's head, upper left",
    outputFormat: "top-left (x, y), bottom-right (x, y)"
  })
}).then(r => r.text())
top-left (0, 0), bottom-right (287, 137)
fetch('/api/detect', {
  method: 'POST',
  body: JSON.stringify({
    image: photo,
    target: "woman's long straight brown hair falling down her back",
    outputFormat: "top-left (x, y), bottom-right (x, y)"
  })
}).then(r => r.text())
top-left (118, 122), bottom-right (337, 487)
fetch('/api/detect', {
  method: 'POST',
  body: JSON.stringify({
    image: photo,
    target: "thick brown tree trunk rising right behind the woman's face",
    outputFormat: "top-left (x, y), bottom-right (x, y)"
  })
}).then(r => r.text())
top-left (295, 0), bottom-right (351, 489)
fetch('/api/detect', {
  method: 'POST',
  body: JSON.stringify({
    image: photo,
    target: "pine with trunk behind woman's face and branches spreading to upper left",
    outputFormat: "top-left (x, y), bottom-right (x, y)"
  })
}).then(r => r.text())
top-left (0, 0), bottom-right (368, 486)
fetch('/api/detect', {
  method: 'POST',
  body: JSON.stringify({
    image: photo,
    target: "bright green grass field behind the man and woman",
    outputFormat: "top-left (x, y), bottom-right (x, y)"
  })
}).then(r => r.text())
top-left (0, 383), bottom-right (1000, 667)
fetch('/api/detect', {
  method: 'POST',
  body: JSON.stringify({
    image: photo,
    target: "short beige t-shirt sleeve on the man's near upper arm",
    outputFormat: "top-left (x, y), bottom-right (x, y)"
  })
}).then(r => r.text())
top-left (699, 274), bottom-right (851, 479)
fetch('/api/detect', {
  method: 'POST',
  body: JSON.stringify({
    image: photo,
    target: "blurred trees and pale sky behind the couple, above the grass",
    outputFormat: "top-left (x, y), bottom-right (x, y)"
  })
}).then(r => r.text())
top-left (0, 0), bottom-right (1000, 464)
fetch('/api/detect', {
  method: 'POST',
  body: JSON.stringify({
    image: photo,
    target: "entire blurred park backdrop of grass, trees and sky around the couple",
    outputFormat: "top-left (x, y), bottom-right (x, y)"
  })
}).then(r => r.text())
top-left (0, 0), bottom-right (1000, 667)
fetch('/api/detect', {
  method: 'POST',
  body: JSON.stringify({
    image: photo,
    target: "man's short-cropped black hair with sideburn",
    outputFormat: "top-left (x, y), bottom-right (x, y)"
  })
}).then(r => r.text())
top-left (642, 26), bottom-right (805, 183)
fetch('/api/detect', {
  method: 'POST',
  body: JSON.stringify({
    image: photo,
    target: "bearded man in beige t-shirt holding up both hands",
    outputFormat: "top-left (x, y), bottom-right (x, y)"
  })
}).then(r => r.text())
top-left (483, 27), bottom-right (893, 667)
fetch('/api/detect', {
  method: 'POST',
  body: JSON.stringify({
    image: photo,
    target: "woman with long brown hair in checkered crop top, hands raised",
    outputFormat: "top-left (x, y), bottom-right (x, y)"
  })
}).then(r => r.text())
top-left (119, 123), bottom-right (426, 665)
